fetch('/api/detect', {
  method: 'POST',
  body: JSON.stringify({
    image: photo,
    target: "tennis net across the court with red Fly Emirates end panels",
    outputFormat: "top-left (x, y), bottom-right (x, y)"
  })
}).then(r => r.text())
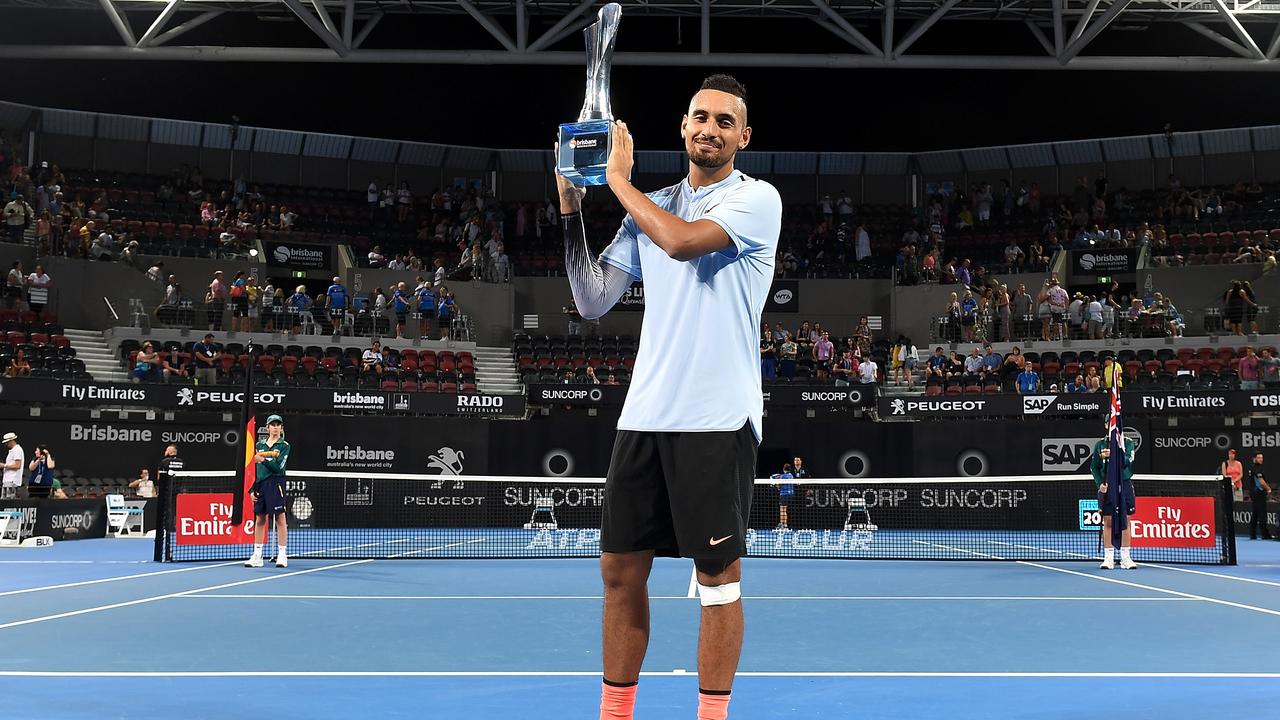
top-left (159, 471), bottom-right (1235, 564)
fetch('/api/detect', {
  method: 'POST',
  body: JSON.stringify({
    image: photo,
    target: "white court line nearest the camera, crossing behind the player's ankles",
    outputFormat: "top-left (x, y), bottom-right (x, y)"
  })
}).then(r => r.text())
top-left (0, 670), bottom-right (1280, 680)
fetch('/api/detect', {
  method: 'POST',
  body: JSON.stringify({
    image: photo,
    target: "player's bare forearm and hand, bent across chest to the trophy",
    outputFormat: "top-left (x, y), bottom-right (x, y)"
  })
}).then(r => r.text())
top-left (605, 120), bottom-right (732, 261)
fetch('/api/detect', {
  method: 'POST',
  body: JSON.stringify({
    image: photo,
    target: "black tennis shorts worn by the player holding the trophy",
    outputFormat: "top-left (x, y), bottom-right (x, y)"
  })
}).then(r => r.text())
top-left (600, 423), bottom-right (756, 561)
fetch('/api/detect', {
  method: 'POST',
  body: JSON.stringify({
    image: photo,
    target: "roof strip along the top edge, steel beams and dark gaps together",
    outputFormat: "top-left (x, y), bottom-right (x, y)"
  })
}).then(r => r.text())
top-left (0, 0), bottom-right (1280, 70)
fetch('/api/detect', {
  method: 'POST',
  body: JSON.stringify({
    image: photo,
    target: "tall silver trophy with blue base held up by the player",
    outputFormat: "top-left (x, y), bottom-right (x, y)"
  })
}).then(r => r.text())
top-left (556, 3), bottom-right (622, 184)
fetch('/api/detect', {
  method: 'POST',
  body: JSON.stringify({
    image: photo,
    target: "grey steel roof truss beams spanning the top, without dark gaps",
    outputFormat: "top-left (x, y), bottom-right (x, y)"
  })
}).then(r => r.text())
top-left (0, 0), bottom-right (1280, 70)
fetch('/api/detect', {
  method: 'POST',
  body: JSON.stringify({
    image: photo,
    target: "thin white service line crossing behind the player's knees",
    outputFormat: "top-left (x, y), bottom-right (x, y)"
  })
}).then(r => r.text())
top-left (172, 593), bottom-right (1193, 602)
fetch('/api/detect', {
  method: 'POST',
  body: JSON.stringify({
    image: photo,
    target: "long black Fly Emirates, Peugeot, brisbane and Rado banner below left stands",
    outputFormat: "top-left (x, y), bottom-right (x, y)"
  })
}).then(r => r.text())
top-left (0, 379), bottom-right (525, 416)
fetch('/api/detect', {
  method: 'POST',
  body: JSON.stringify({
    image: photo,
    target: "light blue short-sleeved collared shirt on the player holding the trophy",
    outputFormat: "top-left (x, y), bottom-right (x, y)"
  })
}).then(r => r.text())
top-left (600, 170), bottom-right (782, 441)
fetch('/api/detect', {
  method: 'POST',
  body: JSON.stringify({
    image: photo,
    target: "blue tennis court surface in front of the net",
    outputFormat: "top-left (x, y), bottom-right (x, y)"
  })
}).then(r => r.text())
top-left (0, 539), bottom-right (1280, 720)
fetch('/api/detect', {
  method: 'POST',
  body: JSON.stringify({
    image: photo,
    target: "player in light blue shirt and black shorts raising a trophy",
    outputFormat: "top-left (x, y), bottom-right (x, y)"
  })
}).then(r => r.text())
top-left (558, 74), bottom-right (782, 720)
